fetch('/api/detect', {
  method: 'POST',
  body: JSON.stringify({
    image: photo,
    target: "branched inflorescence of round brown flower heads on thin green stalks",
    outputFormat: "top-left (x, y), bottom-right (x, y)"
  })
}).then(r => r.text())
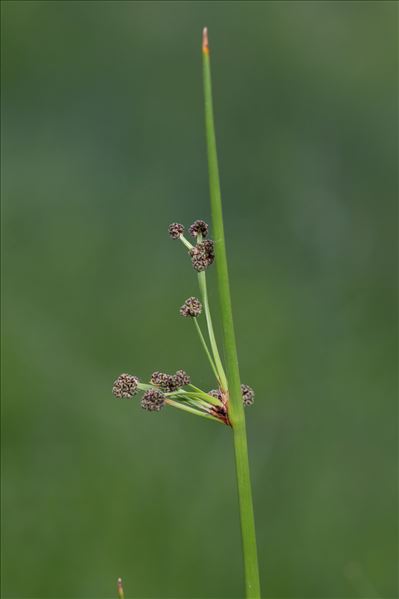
top-left (112, 220), bottom-right (255, 425)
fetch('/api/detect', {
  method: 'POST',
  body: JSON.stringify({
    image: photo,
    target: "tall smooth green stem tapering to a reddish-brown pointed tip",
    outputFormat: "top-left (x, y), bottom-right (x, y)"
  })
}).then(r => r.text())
top-left (202, 29), bottom-right (260, 599)
